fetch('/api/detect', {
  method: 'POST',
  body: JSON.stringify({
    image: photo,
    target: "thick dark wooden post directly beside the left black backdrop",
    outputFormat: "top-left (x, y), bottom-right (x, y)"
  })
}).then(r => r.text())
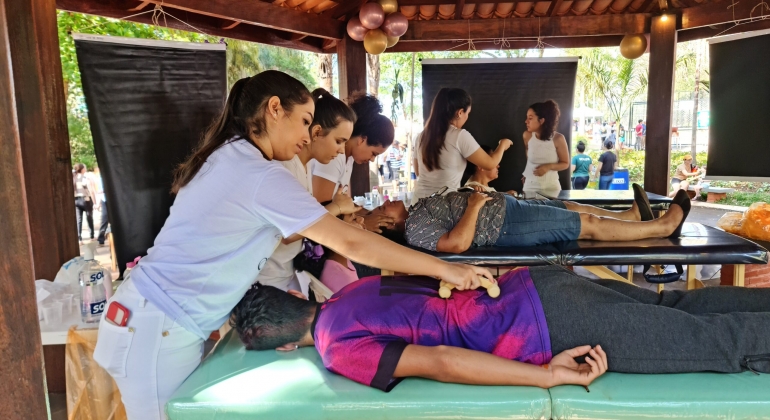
top-left (5, 0), bottom-right (80, 280)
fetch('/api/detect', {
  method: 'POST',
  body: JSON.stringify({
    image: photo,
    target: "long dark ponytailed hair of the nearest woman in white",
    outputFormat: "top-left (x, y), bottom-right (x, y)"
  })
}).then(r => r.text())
top-left (171, 70), bottom-right (310, 193)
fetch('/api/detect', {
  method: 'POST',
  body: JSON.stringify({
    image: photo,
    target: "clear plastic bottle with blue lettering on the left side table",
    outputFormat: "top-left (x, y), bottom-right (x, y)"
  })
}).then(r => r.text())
top-left (80, 242), bottom-right (112, 322)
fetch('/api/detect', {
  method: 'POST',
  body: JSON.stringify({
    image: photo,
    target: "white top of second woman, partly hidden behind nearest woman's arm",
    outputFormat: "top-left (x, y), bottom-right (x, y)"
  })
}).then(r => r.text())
top-left (257, 156), bottom-right (315, 290)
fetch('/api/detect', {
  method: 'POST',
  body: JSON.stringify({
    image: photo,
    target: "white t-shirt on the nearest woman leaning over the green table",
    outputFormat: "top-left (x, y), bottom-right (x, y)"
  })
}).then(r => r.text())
top-left (131, 140), bottom-right (327, 339)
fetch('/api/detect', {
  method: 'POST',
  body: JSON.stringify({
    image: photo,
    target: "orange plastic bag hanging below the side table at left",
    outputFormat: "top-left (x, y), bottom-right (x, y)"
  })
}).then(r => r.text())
top-left (64, 327), bottom-right (127, 420)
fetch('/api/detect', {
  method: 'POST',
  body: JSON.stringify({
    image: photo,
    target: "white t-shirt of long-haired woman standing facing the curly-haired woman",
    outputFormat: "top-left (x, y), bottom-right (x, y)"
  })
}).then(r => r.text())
top-left (412, 125), bottom-right (481, 202)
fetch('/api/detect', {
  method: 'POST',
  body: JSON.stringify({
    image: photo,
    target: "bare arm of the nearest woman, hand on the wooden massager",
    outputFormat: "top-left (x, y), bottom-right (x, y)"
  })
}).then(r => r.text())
top-left (300, 214), bottom-right (494, 290)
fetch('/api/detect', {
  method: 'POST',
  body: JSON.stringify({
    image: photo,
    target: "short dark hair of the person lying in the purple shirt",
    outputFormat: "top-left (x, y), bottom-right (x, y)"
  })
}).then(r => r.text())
top-left (230, 283), bottom-right (316, 350)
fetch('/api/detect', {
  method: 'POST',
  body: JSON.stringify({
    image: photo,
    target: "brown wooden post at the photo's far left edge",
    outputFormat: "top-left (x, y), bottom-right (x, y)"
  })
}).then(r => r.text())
top-left (0, 0), bottom-right (48, 419)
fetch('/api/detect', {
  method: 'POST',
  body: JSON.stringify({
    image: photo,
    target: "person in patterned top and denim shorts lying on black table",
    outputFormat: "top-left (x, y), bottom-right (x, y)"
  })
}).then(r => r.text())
top-left (360, 184), bottom-right (690, 253)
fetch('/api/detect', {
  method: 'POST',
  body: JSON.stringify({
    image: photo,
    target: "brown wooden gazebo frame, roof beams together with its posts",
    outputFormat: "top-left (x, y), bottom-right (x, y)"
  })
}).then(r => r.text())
top-left (0, 0), bottom-right (770, 419)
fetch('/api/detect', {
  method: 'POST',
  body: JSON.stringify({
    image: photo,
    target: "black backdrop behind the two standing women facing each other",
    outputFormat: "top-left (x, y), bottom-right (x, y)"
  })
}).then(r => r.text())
top-left (422, 58), bottom-right (577, 191)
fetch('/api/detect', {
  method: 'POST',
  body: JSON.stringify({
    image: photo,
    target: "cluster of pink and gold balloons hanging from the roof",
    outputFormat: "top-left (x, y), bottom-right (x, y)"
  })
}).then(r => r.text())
top-left (348, 0), bottom-right (409, 55)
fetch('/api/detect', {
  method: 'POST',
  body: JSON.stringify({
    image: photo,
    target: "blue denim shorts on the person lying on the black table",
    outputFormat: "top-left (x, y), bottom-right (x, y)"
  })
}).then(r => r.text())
top-left (495, 195), bottom-right (580, 247)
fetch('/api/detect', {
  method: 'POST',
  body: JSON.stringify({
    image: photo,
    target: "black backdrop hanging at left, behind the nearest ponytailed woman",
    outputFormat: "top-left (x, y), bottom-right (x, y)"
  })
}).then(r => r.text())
top-left (75, 35), bottom-right (227, 273)
